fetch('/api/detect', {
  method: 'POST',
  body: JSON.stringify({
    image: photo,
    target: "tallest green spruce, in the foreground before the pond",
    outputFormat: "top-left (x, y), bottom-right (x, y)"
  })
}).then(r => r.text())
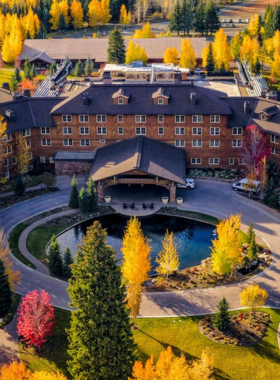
top-left (67, 221), bottom-right (135, 380)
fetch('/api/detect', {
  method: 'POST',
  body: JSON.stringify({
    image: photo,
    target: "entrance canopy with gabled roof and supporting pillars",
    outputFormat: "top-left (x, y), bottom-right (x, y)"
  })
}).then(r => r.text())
top-left (89, 136), bottom-right (186, 202)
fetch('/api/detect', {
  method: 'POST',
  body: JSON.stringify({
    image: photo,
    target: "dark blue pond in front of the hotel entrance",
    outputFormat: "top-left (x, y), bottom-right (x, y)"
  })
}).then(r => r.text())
top-left (57, 214), bottom-right (215, 273)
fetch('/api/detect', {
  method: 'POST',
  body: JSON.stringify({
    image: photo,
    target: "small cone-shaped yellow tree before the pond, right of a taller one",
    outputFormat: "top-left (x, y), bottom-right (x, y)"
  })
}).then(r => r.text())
top-left (156, 231), bottom-right (180, 279)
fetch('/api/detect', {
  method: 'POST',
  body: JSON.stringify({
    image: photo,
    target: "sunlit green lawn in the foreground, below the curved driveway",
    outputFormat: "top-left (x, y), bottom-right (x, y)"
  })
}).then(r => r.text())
top-left (20, 309), bottom-right (280, 380)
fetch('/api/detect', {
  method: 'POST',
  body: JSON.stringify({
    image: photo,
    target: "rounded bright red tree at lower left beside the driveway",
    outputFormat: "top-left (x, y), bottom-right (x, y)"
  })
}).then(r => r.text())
top-left (17, 290), bottom-right (55, 347)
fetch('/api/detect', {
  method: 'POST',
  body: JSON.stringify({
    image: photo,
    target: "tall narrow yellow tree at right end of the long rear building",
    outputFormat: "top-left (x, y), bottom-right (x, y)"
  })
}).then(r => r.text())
top-left (212, 28), bottom-right (230, 70)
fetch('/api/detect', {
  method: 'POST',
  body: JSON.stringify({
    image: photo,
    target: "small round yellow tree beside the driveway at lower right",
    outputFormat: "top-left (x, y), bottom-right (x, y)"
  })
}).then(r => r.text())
top-left (239, 284), bottom-right (268, 317)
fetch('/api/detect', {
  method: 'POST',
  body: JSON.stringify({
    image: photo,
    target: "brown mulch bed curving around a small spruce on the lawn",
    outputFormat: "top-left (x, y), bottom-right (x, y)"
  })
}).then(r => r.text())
top-left (198, 311), bottom-right (270, 347)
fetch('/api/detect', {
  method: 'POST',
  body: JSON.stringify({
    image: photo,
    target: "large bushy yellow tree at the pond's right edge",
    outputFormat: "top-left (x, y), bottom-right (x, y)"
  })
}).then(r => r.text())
top-left (211, 215), bottom-right (241, 275)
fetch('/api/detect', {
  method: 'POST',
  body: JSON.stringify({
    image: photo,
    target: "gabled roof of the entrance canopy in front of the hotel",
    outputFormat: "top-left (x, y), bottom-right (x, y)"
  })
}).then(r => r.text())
top-left (89, 136), bottom-right (186, 183)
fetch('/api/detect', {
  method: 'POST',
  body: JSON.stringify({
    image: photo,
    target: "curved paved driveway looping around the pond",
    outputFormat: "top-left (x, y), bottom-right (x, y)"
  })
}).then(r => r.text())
top-left (0, 180), bottom-right (280, 317)
